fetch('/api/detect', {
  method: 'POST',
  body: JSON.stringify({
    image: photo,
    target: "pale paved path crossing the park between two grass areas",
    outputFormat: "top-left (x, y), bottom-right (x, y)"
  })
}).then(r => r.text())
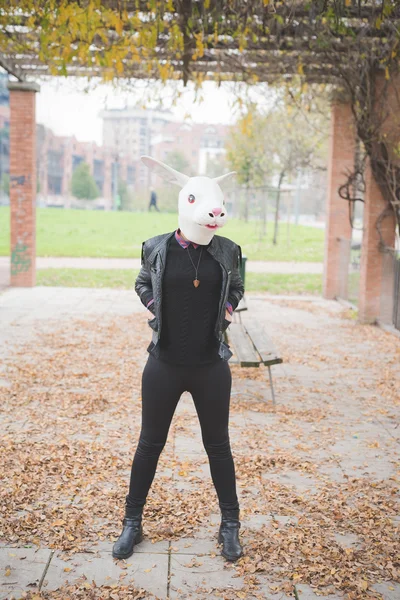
top-left (0, 256), bottom-right (323, 282)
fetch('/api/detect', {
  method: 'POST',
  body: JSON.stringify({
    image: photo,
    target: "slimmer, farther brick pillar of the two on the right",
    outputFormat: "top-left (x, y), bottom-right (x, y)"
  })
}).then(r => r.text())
top-left (323, 100), bottom-right (356, 298)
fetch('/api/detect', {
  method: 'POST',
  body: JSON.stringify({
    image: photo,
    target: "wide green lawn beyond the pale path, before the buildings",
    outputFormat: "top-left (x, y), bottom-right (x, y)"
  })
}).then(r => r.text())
top-left (0, 206), bottom-right (324, 262)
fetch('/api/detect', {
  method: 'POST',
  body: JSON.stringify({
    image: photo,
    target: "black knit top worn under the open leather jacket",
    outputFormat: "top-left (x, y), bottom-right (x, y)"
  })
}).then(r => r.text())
top-left (159, 236), bottom-right (222, 365)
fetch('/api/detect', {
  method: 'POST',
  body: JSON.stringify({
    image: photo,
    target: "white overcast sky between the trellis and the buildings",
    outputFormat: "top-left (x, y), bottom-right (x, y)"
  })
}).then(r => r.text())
top-left (36, 78), bottom-right (266, 144)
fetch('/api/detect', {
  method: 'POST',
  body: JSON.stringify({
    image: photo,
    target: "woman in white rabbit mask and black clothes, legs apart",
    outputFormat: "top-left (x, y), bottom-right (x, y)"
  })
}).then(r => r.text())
top-left (113, 157), bottom-right (244, 561)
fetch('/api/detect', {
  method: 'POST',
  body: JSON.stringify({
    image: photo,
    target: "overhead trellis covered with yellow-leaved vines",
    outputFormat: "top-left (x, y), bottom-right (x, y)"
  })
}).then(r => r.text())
top-left (0, 0), bottom-right (400, 84)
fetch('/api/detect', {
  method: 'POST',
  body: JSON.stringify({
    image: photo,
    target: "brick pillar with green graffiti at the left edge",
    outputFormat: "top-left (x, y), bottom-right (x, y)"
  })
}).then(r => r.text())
top-left (8, 81), bottom-right (40, 287)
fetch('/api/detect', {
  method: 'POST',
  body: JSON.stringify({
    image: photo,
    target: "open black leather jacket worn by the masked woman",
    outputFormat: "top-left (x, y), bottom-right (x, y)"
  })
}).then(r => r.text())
top-left (135, 231), bottom-right (244, 360)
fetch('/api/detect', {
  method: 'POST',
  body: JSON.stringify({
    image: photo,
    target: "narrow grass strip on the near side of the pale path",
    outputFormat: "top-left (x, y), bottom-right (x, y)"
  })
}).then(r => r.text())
top-left (37, 269), bottom-right (322, 294)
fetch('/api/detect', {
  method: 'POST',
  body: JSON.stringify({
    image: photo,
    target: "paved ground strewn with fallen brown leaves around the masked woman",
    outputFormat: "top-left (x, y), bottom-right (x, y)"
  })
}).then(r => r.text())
top-left (0, 297), bottom-right (400, 600)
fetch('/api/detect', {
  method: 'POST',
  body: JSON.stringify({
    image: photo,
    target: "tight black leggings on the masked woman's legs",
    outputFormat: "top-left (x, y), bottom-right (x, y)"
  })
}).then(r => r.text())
top-left (126, 354), bottom-right (239, 509)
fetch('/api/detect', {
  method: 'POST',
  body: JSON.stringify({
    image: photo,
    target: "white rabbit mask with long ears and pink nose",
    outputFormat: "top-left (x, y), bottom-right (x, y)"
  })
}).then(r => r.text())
top-left (141, 156), bottom-right (236, 245)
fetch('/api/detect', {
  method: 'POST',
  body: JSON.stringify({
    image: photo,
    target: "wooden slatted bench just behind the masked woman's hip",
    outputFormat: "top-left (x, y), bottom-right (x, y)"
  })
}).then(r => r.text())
top-left (225, 322), bottom-right (283, 404)
